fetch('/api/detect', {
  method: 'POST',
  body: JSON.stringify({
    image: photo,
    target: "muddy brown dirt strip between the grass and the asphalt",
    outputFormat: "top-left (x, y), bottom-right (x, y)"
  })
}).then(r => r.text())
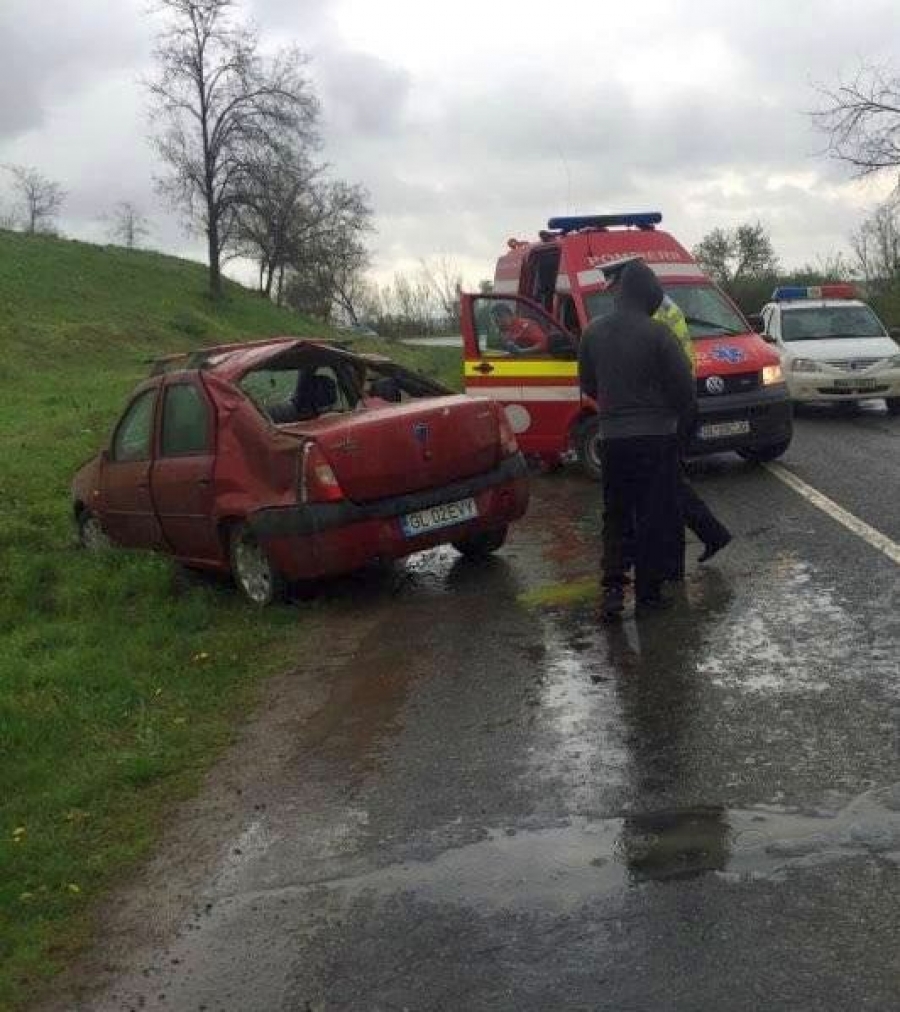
top-left (36, 607), bottom-right (385, 1012)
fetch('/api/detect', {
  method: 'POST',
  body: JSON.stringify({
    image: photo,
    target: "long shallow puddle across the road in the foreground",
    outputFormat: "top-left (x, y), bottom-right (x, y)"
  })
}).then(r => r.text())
top-left (319, 784), bottom-right (900, 913)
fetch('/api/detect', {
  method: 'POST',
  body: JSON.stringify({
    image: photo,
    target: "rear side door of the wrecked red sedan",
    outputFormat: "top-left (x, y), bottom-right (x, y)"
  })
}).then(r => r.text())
top-left (151, 373), bottom-right (225, 564)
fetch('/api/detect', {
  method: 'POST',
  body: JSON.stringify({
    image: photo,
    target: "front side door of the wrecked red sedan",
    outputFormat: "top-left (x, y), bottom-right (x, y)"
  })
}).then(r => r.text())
top-left (98, 385), bottom-right (163, 549)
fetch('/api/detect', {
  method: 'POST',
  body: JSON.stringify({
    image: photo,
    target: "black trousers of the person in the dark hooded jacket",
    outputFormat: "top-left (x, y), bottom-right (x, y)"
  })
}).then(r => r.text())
top-left (600, 436), bottom-right (683, 598)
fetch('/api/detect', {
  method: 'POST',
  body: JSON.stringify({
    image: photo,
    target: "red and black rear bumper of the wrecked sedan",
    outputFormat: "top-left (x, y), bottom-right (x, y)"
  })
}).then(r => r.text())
top-left (249, 453), bottom-right (528, 580)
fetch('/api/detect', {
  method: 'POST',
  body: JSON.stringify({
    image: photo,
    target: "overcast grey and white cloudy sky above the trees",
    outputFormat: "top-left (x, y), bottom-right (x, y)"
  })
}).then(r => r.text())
top-left (0, 0), bottom-right (900, 282)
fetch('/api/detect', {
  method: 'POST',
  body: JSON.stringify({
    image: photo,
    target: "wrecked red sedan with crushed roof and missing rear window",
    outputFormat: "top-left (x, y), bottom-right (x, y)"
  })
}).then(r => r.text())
top-left (73, 338), bottom-right (528, 604)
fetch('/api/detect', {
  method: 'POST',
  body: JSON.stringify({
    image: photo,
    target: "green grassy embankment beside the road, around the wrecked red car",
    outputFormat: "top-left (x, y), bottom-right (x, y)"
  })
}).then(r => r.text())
top-left (0, 232), bottom-right (459, 1010)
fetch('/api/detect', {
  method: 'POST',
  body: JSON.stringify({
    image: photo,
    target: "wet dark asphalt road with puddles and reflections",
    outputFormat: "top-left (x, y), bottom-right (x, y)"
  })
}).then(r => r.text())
top-left (59, 402), bottom-right (900, 1012)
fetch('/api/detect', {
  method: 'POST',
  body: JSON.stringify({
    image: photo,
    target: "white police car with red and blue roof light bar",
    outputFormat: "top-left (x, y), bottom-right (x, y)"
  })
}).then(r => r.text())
top-left (760, 284), bottom-right (900, 415)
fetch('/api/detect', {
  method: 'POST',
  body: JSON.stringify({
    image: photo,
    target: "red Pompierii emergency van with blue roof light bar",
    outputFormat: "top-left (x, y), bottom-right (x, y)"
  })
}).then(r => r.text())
top-left (462, 213), bottom-right (793, 477)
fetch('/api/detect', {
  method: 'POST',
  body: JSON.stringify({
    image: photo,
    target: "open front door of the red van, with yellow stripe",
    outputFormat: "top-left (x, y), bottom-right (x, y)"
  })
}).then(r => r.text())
top-left (461, 294), bottom-right (585, 462)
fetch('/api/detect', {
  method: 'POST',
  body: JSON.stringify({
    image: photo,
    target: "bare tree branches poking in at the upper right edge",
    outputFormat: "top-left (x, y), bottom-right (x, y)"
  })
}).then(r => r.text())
top-left (812, 65), bottom-right (900, 176)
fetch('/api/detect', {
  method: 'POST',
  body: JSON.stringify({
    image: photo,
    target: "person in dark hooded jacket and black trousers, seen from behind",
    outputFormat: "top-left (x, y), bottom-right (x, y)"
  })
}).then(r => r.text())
top-left (578, 260), bottom-right (696, 617)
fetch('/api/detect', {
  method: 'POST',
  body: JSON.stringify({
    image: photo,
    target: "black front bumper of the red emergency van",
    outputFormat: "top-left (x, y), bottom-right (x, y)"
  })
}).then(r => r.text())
top-left (687, 384), bottom-right (794, 456)
